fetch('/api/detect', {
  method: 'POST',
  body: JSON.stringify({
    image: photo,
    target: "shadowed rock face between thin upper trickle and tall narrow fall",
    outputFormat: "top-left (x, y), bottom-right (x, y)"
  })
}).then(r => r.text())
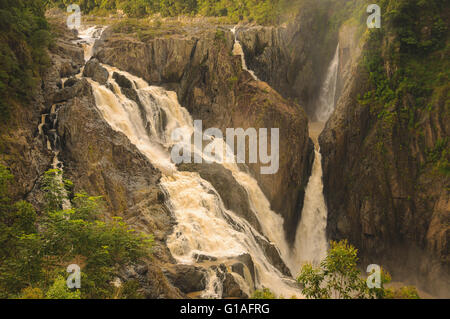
top-left (237, 2), bottom-right (337, 119)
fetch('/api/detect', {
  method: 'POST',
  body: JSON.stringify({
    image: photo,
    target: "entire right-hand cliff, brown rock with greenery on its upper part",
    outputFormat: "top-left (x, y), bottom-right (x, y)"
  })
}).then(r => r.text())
top-left (320, 2), bottom-right (450, 297)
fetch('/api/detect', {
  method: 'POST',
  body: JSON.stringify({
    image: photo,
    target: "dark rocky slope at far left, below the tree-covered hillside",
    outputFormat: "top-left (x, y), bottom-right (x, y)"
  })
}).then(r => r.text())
top-left (0, 20), bottom-right (84, 207)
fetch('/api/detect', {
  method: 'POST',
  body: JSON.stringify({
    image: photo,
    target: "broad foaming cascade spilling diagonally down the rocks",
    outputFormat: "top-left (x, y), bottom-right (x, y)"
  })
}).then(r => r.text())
top-left (81, 26), bottom-right (301, 298)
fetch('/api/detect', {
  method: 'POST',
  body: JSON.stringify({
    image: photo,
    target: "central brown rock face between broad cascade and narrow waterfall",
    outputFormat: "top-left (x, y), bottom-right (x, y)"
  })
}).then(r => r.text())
top-left (95, 29), bottom-right (313, 242)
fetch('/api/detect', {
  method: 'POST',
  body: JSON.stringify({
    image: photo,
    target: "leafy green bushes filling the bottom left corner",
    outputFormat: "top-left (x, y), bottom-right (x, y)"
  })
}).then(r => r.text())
top-left (0, 166), bottom-right (153, 299)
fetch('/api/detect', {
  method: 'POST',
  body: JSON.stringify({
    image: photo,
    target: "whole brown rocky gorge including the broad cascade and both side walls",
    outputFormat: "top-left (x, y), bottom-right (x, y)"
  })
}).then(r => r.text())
top-left (1, 0), bottom-right (450, 298)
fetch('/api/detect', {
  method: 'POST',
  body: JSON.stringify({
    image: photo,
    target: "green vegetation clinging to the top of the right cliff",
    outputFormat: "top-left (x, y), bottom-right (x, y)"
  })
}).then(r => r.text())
top-left (360, 0), bottom-right (450, 176)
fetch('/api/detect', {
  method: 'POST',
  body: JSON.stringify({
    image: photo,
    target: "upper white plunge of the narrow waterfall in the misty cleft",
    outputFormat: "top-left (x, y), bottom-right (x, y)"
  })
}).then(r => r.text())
top-left (315, 44), bottom-right (339, 122)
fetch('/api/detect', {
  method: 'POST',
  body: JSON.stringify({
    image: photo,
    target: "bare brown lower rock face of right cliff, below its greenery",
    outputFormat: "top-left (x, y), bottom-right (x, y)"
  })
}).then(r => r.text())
top-left (320, 31), bottom-right (450, 297)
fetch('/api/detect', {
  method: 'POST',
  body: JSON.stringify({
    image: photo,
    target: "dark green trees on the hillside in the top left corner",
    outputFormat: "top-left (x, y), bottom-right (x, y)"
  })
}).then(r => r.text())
top-left (0, 0), bottom-right (52, 122)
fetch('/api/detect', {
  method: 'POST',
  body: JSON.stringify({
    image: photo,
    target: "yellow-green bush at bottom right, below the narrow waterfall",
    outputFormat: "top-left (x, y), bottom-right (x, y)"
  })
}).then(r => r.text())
top-left (297, 240), bottom-right (419, 299)
